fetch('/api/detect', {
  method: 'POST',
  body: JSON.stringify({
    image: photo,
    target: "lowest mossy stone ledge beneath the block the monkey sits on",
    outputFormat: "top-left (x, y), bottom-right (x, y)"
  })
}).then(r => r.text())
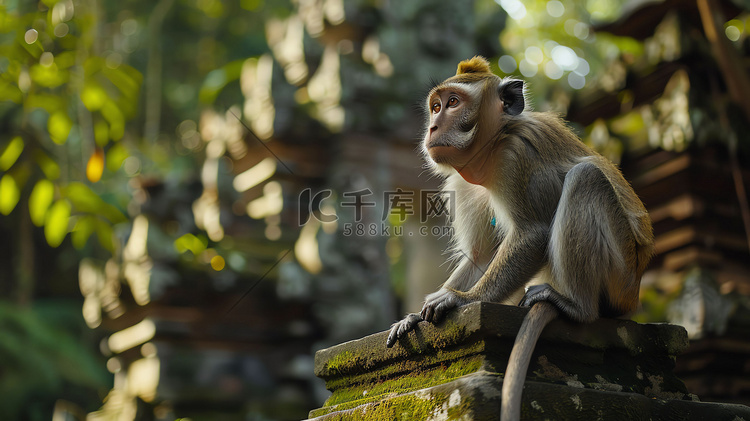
top-left (312, 372), bottom-right (750, 421)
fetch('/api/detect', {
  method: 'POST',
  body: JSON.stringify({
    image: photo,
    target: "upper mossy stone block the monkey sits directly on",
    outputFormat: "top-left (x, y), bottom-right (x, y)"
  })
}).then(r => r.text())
top-left (310, 303), bottom-right (704, 419)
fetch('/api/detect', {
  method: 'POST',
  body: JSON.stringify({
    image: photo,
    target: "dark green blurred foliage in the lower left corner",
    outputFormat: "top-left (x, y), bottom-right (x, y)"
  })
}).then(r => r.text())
top-left (0, 301), bottom-right (109, 420)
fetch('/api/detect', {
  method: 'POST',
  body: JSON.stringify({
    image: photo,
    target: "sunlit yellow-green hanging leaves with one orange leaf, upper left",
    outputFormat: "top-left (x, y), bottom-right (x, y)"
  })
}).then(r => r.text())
top-left (0, 0), bottom-right (132, 251)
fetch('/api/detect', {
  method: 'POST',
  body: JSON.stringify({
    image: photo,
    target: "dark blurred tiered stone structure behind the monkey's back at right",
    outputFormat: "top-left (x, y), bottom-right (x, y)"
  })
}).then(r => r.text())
top-left (567, 0), bottom-right (750, 404)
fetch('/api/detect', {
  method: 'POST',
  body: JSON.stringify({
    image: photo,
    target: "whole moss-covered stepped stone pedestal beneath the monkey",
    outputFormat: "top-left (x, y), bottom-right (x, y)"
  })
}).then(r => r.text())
top-left (310, 303), bottom-right (750, 420)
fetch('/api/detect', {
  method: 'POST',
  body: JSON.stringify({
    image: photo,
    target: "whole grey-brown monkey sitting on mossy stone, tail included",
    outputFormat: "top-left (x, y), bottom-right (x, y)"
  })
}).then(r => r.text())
top-left (386, 56), bottom-right (654, 421)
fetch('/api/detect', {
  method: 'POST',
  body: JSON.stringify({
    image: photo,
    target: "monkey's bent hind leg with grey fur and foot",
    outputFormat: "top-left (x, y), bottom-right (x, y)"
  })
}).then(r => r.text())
top-left (536, 161), bottom-right (638, 322)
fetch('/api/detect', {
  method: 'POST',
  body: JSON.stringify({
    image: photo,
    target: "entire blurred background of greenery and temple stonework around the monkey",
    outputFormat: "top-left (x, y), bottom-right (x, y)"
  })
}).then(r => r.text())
top-left (0, 0), bottom-right (750, 421)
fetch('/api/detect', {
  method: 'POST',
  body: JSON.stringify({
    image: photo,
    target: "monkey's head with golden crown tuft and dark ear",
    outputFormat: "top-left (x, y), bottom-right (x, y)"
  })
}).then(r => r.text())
top-left (422, 56), bottom-right (525, 184)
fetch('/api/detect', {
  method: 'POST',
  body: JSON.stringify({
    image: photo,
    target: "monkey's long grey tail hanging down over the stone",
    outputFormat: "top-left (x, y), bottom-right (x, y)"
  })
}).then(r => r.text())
top-left (500, 301), bottom-right (558, 421)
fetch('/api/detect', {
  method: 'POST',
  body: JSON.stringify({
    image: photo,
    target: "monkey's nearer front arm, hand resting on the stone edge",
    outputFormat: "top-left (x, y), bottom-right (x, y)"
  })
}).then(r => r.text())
top-left (420, 224), bottom-right (549, 322)
